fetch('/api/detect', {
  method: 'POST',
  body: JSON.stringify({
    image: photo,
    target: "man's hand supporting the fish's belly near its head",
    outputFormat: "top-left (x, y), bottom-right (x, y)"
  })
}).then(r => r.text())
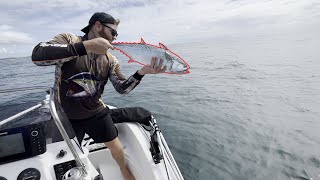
top-left (138, 57), bottom-right (167, 76)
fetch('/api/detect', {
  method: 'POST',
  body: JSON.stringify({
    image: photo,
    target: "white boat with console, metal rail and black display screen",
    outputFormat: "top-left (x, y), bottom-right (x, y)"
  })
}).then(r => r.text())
top-left (0, 88), bottom-right (183, 180)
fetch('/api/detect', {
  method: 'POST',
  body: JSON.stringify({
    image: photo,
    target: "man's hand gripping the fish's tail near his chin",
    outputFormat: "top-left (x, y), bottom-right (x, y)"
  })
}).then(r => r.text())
top-left (83, 37), bottom-right (114, 54)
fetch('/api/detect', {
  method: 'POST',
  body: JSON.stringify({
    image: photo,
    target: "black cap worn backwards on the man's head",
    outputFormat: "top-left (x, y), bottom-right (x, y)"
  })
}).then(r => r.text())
top-left (81, 12), bottom-right (116, 34)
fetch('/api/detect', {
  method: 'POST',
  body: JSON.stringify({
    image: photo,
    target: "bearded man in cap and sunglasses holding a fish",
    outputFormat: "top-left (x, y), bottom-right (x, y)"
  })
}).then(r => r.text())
top-left (32, 12), bottom-right (166, 180)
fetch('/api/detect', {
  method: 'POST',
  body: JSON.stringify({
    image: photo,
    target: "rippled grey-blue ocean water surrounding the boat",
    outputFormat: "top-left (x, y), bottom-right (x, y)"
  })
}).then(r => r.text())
top-left (0, 36), bottom-right (320, 180)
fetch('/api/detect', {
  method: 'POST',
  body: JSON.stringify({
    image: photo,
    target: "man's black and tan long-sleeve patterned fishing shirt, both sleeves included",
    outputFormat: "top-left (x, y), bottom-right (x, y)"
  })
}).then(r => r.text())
top-left (32, 33), bottom-right (143, 119)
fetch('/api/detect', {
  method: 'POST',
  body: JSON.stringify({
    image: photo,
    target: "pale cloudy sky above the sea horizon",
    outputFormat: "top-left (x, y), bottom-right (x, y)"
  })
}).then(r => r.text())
top-left (0, 0), bottom-right (320, 58)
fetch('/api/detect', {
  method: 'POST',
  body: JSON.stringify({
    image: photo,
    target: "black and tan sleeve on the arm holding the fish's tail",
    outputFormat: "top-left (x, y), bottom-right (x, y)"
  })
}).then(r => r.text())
top-left (31, 33), bottom-right (87, 66)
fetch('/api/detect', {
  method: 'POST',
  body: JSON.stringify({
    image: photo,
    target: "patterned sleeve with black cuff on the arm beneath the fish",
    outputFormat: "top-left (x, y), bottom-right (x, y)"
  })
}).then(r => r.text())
top-left (108, 54), bottom-right (143, 94)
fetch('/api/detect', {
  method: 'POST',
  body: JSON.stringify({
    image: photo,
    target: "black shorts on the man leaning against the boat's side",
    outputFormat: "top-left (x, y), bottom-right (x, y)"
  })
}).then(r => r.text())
top-left (70, 107), bottom-right (151, 143)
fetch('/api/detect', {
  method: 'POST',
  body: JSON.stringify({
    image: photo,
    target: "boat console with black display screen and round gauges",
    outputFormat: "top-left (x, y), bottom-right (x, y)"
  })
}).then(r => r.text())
top-left (0, 95), bottom-right (99, 180)
